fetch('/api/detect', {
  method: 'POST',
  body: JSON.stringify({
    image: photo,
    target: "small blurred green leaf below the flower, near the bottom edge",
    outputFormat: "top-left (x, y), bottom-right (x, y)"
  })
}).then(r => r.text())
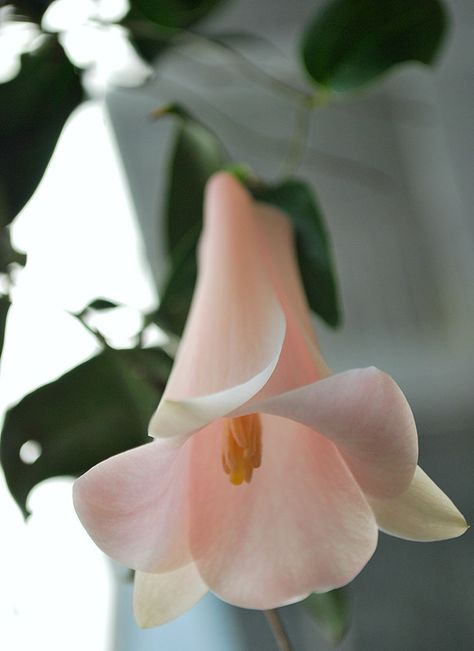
top-left (302, 588), bottom-right (351, 643)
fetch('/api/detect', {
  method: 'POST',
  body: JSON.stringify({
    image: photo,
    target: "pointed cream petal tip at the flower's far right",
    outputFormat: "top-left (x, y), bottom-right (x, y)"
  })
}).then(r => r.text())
top-left (369, 466), bottom-right (469, 542)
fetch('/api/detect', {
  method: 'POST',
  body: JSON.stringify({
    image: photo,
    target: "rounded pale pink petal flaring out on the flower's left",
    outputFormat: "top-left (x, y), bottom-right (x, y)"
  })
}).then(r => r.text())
top-left (73, 441), bottom-right (190, 572)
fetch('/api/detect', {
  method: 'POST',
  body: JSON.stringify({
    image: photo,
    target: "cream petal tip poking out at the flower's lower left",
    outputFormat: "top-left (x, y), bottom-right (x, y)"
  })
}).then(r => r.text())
top-left (133, 563), bottom-right (208, 628)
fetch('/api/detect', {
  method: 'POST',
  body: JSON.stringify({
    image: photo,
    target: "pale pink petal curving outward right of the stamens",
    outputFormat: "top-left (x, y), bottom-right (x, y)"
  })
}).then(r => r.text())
top-left (241, 367), bottom-right (418, 498)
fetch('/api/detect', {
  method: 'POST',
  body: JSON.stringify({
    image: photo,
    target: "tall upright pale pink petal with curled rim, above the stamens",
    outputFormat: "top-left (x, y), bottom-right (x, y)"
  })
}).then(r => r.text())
top-left (150, 173), bottom-right (285, 437)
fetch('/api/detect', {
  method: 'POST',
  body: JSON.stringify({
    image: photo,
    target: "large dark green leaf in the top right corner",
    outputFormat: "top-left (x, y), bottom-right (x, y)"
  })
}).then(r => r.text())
top-left (302, 0), bottom-right (447, 92)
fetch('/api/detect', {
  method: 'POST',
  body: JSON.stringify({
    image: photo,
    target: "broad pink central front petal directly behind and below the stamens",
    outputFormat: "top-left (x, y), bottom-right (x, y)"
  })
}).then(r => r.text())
top-left (190, 416), bottom-right (377, 609)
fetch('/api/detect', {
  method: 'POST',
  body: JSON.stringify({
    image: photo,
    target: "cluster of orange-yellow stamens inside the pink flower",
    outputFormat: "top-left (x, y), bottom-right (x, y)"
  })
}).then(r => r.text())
top-left (222, 414), bottom-right (262, 486)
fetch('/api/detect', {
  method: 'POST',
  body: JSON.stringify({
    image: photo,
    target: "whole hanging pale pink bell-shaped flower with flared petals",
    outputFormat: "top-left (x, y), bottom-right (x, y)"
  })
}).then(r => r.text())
top-left (74, 173), bottom-right (467, 626)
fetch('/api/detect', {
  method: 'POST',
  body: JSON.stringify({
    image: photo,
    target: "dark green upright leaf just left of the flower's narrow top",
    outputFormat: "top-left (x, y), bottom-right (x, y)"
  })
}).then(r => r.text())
top-left (166, 106), bottom-right (225, 251)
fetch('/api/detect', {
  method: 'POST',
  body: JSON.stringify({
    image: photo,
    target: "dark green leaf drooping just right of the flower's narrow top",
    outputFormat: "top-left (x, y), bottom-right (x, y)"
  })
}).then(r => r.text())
top-left (253, 179), bottom-right (341, 327)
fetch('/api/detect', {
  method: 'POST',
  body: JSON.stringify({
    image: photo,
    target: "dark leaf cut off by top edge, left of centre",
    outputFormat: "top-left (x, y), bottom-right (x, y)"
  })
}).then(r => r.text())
top-left (130, 0), bottom-right (228, 28)
